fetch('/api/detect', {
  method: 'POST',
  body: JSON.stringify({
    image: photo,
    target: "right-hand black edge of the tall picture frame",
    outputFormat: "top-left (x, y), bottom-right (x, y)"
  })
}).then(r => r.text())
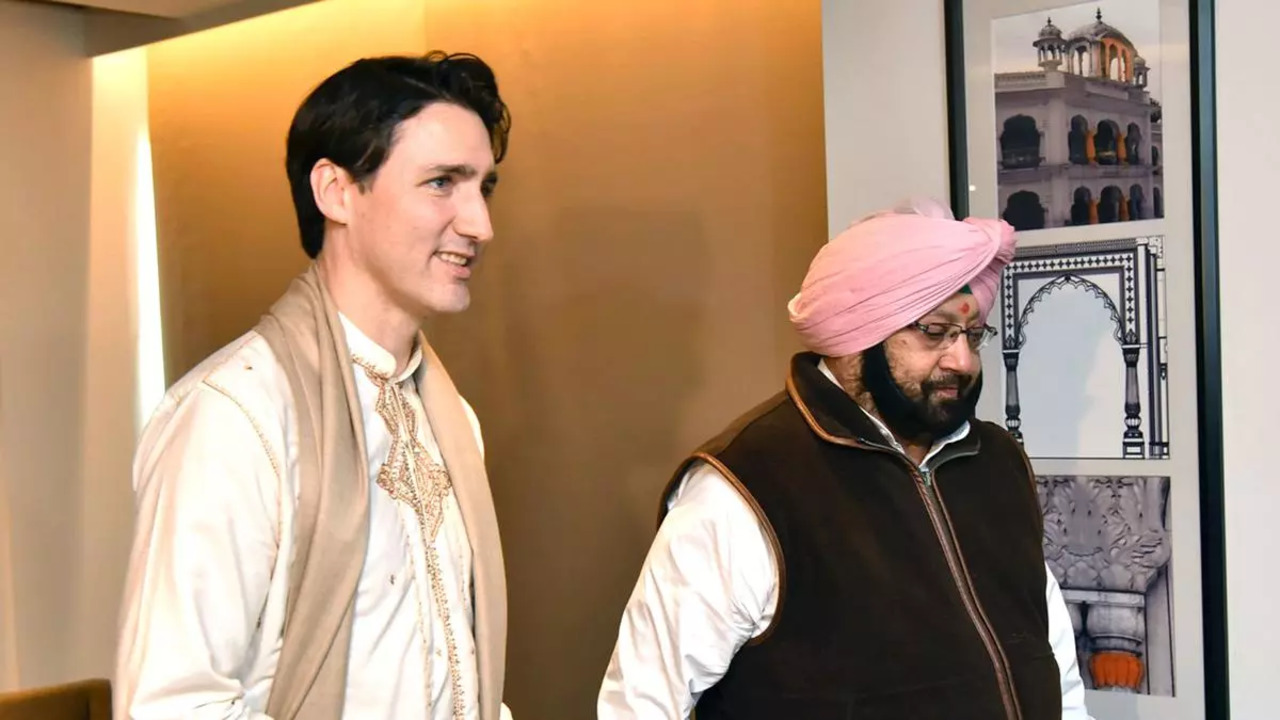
top-left (1190, 0), bottom-right (1230, 720)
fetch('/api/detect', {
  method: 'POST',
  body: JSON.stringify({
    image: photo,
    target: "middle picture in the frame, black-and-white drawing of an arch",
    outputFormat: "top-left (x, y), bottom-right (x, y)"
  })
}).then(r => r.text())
top-left (1001, 237), bottom-right (1170, 460)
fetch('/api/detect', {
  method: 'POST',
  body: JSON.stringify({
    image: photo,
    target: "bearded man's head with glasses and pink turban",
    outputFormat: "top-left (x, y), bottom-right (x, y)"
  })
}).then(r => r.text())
top-left (787, 200), bottom-right (1014, 448)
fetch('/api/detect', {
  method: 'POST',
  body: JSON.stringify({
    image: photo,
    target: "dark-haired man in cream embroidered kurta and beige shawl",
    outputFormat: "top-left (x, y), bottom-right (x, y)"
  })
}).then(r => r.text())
top-left (115, 53), bottom-right (511, 720)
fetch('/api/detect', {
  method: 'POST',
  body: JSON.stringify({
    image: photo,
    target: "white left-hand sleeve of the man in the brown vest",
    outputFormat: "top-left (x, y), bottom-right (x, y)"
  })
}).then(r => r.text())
top-left (596, 462), bottom-right (778, 720)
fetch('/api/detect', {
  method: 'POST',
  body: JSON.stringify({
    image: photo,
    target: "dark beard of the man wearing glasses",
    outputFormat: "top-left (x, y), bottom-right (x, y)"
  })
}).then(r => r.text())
top-left (861, 342), bottom-right (982, 445)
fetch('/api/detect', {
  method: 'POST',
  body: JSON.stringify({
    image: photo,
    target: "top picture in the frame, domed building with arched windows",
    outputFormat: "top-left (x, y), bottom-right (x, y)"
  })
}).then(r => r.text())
top-left (992, 0), bottom-right (1165, 231)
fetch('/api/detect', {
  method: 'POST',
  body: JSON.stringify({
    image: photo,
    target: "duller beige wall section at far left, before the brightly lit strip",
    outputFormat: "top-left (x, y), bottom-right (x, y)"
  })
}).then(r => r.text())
top-left (0, 0), bottom-right (91, 684)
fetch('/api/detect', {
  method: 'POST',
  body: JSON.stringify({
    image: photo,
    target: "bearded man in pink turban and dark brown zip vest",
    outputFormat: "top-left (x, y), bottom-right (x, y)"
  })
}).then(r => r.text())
top-left (596, 200), bottom-right (1089, 720)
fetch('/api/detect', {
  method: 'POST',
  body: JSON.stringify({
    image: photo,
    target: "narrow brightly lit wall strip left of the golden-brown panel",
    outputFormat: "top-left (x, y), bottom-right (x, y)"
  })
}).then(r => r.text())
top-left (80, 50), bottom-right (153, 678)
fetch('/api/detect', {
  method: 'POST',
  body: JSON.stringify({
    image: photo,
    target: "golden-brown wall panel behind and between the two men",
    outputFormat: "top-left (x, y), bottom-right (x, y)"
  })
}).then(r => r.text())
top-left (150, 0), bottom-right (827, 719)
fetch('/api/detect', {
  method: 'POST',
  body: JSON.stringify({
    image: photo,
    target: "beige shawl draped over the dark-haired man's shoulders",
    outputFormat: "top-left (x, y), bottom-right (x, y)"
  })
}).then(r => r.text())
top-left (257, 265), bottom-right (507, 720)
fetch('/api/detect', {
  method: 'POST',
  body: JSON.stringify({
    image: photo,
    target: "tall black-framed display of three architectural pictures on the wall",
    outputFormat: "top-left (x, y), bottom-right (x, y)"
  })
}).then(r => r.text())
top-left (945, 0), bottom-right (1228, 720)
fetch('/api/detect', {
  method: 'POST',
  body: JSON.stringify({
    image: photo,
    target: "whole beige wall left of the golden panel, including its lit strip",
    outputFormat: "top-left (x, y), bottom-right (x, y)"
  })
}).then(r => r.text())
top-left (0, 0), bottom-right (160, 688)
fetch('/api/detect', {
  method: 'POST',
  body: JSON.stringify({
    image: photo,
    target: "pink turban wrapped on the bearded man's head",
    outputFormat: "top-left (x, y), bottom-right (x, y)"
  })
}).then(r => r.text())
top-left (787, 204), bottom-right (1015, 357)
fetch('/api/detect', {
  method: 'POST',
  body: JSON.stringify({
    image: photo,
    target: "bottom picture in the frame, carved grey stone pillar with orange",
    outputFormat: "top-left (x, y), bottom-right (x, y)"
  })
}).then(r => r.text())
top-left (1036, 475), bottom-right (1170, 692)
